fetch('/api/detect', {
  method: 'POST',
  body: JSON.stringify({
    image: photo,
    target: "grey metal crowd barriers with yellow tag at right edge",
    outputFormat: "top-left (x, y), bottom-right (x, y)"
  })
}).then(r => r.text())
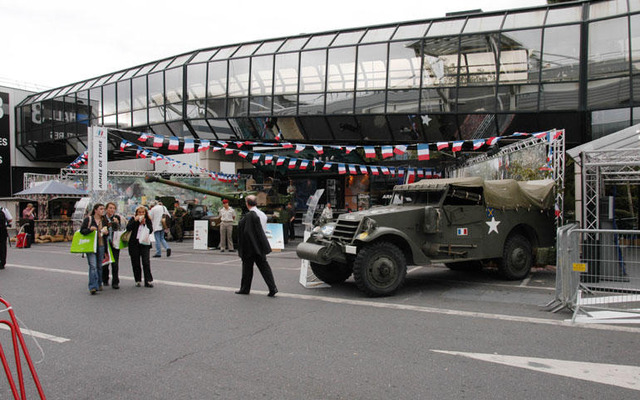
top-left (553, 224), bottom-right (640, 323)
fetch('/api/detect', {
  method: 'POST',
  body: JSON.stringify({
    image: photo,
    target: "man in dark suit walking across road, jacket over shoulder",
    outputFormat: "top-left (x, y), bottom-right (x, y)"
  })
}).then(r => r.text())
top-left (236, 195), bottom-right (278, 297)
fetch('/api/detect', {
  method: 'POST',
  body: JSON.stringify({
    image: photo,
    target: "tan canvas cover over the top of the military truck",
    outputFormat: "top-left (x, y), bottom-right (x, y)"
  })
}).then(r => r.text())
top-left (394, 177), bottom-right (554, 209)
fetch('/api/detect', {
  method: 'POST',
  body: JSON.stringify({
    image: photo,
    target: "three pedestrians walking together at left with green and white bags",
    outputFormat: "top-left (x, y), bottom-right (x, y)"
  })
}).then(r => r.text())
top-left (80, 203), bottom-right (153, 295)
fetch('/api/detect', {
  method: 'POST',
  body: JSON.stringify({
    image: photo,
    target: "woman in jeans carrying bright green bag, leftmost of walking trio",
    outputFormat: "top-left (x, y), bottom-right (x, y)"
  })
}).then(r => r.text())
top-left (80, 203), bottom-right (109, 295)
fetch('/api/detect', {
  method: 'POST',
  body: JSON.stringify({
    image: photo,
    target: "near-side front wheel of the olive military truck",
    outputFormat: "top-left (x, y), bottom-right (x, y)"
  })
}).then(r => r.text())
top-left (353, 242), bottom-right (407, 297)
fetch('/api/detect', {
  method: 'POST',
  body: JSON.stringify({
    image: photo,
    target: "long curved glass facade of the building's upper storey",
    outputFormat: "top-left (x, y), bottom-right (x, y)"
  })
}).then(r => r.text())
top-left (16, 0), bottom-right (640, 161)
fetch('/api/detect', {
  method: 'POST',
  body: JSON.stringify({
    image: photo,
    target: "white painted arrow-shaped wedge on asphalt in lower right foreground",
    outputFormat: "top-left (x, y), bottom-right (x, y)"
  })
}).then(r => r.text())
top-left (431, 350), bottom-right (640, 390)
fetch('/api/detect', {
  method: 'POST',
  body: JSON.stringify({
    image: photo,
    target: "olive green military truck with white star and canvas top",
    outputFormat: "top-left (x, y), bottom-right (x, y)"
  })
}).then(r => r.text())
top-left (296, 177), bottom-right (555, 296)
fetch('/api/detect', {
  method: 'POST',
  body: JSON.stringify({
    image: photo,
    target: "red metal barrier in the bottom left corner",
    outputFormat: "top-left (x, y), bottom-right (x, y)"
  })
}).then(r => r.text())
top-left (0, 297), bottom-right (46, 400)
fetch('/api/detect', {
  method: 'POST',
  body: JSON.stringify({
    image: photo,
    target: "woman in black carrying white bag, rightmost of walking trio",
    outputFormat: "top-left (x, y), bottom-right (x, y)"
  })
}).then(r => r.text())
top-left (127, 206), bottom-right (153, 287)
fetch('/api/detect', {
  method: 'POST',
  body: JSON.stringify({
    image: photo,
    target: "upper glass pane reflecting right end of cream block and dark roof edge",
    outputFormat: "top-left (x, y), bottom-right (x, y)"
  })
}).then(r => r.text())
top-left (499, 29), bottom-right (542, 83)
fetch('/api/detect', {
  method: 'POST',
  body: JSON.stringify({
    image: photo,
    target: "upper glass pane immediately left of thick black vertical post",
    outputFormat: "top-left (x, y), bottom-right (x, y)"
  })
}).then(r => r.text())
top-left (542, 25), bottom-right (580, 82)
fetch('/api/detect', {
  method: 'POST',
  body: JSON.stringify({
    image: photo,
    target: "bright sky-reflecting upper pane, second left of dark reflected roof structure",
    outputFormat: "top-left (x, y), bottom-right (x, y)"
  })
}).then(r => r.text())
top-left (357, 43), bottom-right (387, 90)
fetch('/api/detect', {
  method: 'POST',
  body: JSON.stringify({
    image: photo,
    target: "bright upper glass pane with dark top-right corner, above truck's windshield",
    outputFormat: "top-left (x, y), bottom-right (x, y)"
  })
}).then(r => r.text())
top-left (388, 42), bottom-right (423, 90)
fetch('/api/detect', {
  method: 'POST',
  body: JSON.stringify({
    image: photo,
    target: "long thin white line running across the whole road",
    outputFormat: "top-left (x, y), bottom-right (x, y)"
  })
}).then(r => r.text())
top-left (7, 264), bottom-right (640, 333)
